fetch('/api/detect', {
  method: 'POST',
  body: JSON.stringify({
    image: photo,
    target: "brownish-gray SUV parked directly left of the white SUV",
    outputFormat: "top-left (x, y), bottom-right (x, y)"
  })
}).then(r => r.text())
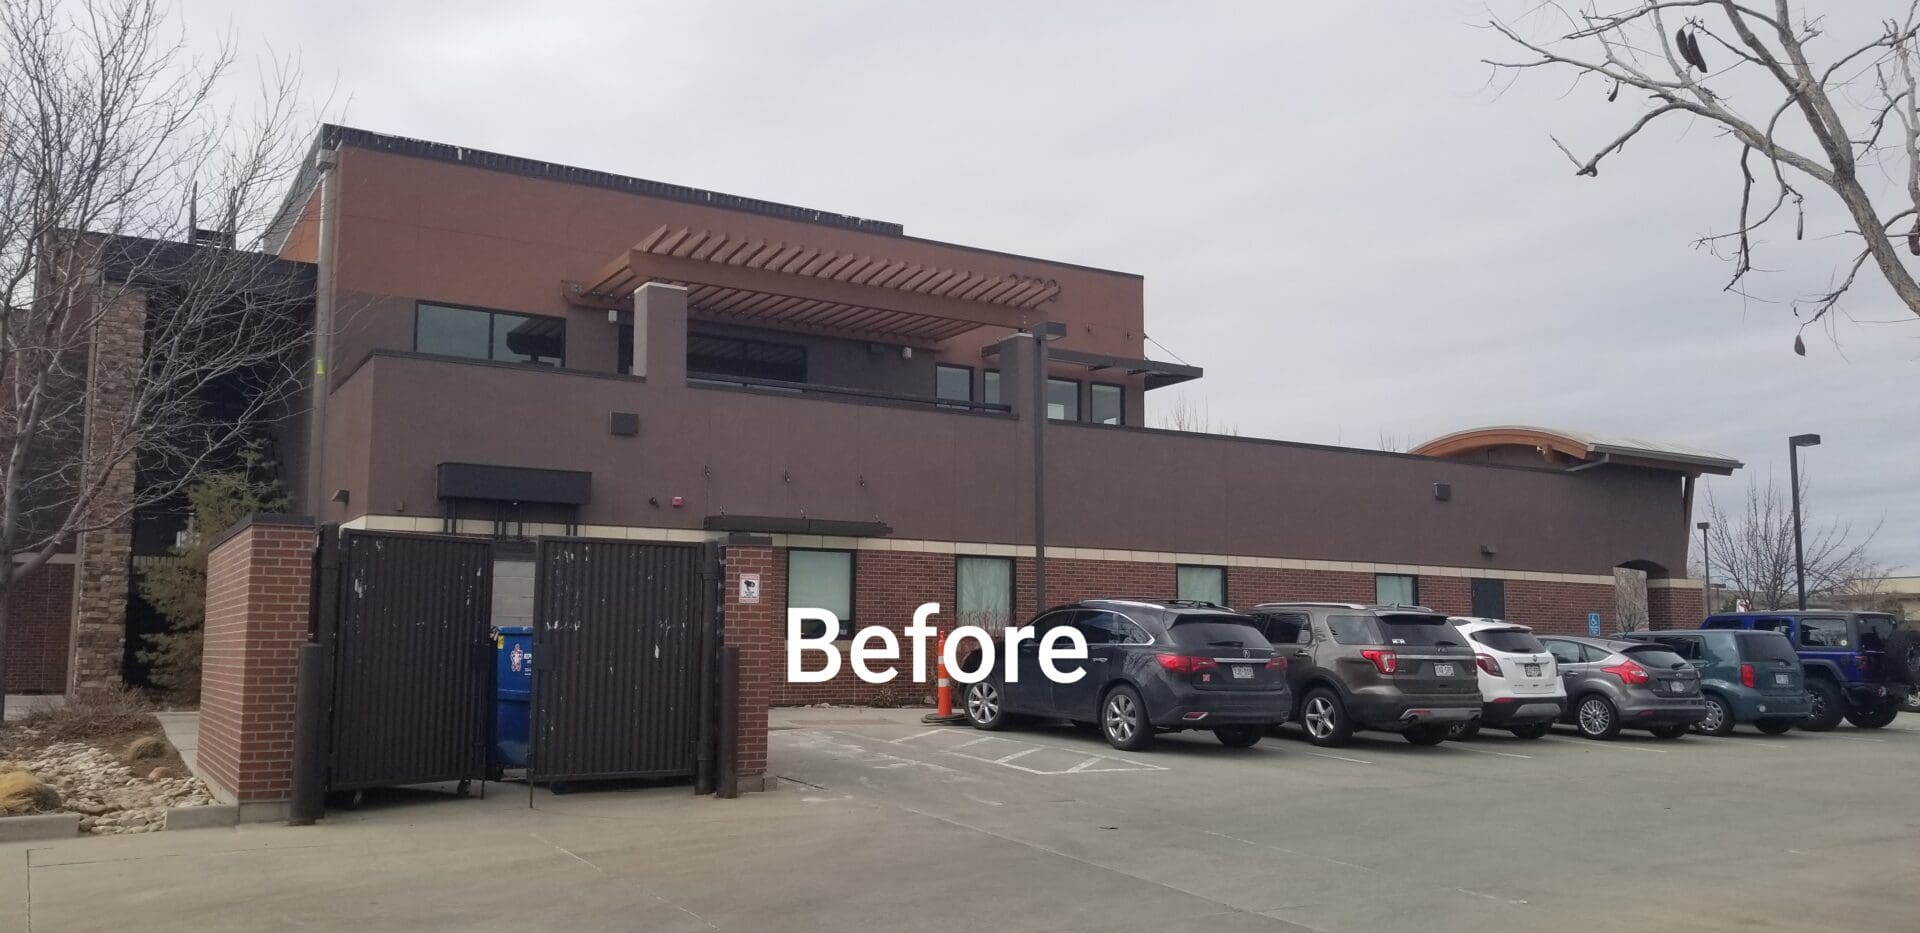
top-left (1248, 603), bottom-right (1480, 747)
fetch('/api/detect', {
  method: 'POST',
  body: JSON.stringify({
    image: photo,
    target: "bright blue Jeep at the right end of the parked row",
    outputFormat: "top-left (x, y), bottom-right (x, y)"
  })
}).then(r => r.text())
top-left (1699, 609), bottom-right (1920, 731)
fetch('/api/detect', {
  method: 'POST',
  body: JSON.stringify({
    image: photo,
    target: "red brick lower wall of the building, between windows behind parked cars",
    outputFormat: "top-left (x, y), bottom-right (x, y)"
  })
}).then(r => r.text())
top-left (760, 547), bottom-right (1620, 706)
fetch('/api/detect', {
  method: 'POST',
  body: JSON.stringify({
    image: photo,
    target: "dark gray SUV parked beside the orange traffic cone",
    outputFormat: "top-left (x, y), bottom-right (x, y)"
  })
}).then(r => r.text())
top-left (960, 599), bottom-right (1292, 751)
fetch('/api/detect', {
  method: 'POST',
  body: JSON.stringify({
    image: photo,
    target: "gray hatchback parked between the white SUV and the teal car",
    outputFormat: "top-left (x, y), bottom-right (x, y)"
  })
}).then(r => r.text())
top-left (1540, 635), bottom-right (1707, 739)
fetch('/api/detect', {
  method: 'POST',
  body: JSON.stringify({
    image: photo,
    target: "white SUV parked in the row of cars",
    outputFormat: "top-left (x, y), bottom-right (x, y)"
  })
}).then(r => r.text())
top-left (1448, 616), bottom-right (1567, 739)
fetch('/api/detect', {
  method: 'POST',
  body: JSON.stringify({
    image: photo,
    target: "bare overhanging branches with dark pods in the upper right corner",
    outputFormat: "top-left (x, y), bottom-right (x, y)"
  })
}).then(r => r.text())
top-left (1488, 0), bottom-right (1920, 345)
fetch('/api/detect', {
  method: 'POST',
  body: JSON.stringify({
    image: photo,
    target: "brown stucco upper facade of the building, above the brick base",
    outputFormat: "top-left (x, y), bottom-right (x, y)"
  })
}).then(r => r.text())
top-left (270, 129), bottom-right (1728, 576)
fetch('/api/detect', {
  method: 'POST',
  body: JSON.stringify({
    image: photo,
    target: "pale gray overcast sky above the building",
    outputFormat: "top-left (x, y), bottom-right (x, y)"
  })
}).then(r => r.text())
top-left (191, 0), bottom-right (1920, 572)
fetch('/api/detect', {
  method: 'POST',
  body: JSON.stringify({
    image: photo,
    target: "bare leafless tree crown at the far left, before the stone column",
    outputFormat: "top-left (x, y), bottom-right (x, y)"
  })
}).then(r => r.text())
top-left (0, 0), bottom-right (305, 714)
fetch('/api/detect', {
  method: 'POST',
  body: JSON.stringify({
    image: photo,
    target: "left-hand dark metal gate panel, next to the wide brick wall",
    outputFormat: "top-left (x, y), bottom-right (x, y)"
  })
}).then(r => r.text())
top-left (315, 532), bottom-right (493, 791)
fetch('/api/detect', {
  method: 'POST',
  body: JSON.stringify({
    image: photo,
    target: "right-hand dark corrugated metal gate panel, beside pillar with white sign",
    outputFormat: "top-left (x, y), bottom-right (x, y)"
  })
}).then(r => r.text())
top-left (528, 538), bottom-right (718, 781)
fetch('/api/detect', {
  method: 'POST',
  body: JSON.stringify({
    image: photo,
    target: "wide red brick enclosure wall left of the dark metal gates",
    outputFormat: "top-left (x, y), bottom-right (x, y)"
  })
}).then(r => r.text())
top-left (198, 514), bottom-right (313, 818)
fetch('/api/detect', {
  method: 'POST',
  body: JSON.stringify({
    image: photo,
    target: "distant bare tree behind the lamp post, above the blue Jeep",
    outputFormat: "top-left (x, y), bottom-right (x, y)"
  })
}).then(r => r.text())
top-left (1707, 476), bottom-right (1880, 609)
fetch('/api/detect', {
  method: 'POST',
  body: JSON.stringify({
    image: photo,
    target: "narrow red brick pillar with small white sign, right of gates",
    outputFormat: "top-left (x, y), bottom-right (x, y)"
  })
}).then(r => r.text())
top-left (722, 538), bottom-right (787, 791)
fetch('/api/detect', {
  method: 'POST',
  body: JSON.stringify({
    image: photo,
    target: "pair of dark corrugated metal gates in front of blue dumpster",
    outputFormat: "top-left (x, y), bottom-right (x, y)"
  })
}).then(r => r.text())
top-left (314, 528), bottom-right (718, 791)
